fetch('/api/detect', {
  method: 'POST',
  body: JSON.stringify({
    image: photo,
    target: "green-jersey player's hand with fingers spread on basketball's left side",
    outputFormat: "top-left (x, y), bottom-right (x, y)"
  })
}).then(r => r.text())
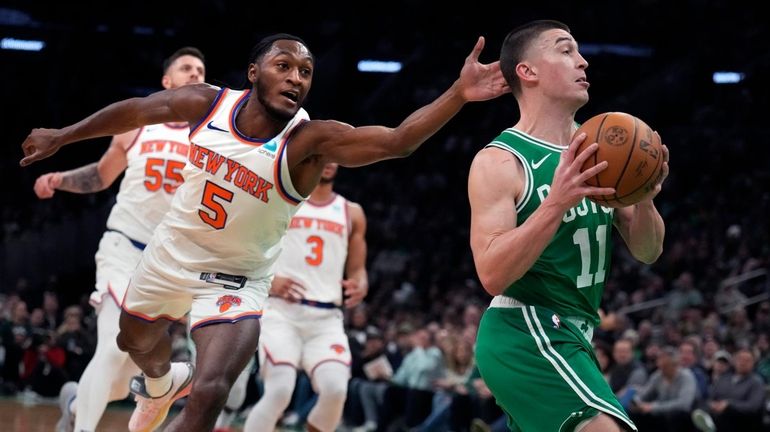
top-left (548, 133), bottom-right (615, 211)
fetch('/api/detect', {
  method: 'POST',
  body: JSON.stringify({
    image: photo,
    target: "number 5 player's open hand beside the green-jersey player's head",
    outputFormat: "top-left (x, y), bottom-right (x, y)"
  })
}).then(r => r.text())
top-left (459, 36), bottom-right (511, 102)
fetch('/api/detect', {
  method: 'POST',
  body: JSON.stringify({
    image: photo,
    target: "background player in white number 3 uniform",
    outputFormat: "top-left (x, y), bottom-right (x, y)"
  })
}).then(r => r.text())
top-left (244, 163), bottom-right (368, 432)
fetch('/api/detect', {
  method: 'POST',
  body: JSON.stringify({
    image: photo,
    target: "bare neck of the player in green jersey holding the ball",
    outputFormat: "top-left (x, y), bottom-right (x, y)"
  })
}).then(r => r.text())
top-left (514, 98), bottom-right (577, 146)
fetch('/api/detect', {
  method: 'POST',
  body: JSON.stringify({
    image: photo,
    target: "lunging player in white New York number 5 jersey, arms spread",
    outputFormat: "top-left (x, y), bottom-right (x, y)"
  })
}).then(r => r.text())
top-left (21, 34), bottom-right (510, 432)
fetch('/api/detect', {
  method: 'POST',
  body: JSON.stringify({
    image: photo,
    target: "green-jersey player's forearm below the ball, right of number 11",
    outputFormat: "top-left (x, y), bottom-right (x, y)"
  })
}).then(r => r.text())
top-left (626, 200), bottom-right (666, 264)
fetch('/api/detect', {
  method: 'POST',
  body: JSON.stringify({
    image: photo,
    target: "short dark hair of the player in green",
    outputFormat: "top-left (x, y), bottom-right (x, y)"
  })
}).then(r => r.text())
top-left (500, 20), bottom-right (570, 95)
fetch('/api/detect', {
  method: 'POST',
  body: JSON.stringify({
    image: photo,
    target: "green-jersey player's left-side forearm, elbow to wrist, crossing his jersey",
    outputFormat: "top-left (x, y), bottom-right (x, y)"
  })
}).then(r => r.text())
top-left (476, 199), bottom-right (564, 295)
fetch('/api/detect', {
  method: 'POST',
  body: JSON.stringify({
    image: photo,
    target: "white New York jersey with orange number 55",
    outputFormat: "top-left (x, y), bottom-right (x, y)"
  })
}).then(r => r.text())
top-left (107, 124), bottom-right (190, 244)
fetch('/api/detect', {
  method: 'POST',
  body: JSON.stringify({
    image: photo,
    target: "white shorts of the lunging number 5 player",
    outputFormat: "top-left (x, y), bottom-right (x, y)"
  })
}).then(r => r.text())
top-left (121, 240), bottom-right (270, 331)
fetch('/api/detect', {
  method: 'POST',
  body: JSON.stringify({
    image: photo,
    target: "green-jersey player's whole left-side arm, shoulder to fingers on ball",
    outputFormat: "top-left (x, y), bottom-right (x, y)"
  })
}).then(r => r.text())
top-left (468, 134), bottom-right (614, 295)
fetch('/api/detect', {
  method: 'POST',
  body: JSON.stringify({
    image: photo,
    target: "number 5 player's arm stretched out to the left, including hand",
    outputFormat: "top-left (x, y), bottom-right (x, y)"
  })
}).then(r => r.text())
top-left (21, 84), bottom-right (218, 166)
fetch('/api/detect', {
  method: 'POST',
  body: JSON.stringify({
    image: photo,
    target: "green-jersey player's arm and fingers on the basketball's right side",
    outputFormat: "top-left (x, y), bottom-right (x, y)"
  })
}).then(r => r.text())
top-left (615, 145), bottom-right (668, 264)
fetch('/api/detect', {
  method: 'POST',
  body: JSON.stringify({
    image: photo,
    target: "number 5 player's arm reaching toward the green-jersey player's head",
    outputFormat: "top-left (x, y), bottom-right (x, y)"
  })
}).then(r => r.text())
top-left (302, 37), bottom-right (510, 167)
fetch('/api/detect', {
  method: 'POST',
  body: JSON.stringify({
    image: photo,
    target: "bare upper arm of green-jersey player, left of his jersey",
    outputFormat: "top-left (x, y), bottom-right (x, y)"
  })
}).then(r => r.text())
top-left (468, 149), bottom-right (521, 257)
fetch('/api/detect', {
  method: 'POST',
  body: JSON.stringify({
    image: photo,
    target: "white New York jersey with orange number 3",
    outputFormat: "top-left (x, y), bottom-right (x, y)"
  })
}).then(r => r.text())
top-left (275, 195), bottom-right (352, 305)
